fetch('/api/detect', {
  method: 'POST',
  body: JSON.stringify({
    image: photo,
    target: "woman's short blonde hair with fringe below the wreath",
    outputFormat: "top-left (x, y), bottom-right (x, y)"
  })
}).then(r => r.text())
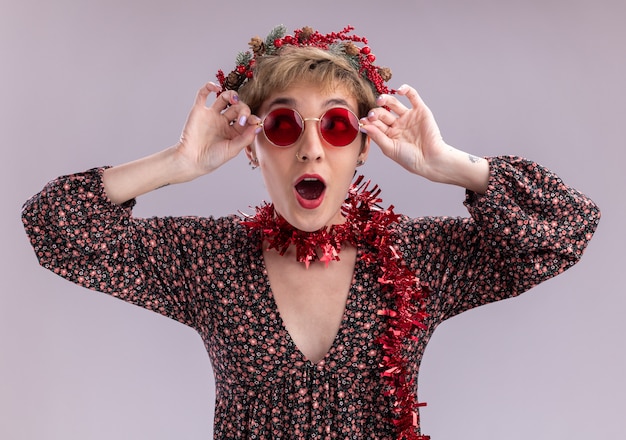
top-left (239, 47), bottom-right (376, 117)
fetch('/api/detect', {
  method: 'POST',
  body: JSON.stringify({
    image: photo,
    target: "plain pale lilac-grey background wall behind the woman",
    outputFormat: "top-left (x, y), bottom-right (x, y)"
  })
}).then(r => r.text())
top-left (0, 0), bottom-right (626, 440)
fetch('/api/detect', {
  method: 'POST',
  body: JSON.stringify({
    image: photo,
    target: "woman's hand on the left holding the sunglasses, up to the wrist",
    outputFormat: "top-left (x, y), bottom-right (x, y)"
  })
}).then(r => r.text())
top-left (176, 82), bottom-right (260, 178)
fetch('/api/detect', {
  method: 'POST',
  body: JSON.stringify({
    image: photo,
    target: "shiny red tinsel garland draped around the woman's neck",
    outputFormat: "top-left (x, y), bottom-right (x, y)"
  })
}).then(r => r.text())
top-left (242, 176), bottom-right (430, 440)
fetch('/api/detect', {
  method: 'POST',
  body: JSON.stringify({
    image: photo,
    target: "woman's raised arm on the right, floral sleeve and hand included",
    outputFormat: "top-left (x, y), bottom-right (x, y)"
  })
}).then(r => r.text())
top-left (362, 86), bottom-right (600, 319)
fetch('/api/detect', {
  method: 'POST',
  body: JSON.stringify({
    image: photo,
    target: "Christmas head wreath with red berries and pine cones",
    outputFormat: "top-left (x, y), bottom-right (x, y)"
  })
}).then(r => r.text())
top-left (216, 25), bottom-right (395, 96)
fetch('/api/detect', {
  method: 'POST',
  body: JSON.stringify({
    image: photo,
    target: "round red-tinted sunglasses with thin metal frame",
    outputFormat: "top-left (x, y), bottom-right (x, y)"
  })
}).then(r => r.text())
top-left (259, 107), bottom-right (361, 148)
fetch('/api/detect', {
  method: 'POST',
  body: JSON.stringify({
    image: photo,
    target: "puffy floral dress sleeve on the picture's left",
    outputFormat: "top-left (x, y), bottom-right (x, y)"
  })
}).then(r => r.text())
top-left (22, 168), bottom-right (229, 326)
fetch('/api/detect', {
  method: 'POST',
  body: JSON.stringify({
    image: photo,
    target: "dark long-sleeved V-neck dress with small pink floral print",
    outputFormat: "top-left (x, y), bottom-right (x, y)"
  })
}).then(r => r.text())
top-left (23, 157), bottom-right (600, 440)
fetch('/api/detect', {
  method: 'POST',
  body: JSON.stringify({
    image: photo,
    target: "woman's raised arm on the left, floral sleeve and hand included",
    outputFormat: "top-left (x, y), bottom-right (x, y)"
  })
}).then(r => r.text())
top-left (22, 84), bottom-right (255, 325)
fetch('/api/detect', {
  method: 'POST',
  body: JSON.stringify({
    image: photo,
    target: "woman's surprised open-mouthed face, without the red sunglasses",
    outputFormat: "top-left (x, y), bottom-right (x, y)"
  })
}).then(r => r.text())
top-left (247, 84), bottom-right (369, 232)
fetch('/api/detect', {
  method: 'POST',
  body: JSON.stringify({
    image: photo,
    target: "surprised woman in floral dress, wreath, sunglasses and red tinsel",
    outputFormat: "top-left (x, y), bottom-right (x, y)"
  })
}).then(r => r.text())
top-left (23, 27), bottom-right (599, 439)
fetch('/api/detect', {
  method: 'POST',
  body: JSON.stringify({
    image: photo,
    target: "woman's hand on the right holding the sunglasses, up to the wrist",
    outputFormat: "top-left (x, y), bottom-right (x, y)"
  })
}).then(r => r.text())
top-left (361, 85), bottom-right (449, 179)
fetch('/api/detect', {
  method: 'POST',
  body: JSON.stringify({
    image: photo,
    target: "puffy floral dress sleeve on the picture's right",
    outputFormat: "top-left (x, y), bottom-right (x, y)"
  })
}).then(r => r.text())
top-left (394, 157), bottom-right (600, 322)
